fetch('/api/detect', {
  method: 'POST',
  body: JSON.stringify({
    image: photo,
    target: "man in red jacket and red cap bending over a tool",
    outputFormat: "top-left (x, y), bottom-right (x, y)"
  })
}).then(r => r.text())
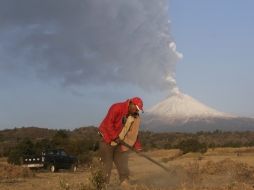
top-left (99, 97), bottom-right (143, 184)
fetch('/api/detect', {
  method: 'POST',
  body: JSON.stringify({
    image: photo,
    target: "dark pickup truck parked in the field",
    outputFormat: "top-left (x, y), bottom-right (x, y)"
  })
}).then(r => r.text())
top-left (22, 149), bottom-right (78, 172)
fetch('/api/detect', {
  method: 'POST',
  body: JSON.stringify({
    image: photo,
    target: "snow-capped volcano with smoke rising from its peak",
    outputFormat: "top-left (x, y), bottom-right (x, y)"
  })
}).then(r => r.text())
top-left (143, 90), bottom-right (254, 132)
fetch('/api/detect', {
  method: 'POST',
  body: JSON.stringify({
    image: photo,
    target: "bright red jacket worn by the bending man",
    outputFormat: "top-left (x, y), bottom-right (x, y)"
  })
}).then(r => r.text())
top-left (99, 100), bottom-right (141, 150)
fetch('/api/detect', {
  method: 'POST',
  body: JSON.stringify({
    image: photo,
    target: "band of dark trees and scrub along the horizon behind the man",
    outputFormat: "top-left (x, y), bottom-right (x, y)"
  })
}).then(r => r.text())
top-left (0, 126), bottom-right (254, 165)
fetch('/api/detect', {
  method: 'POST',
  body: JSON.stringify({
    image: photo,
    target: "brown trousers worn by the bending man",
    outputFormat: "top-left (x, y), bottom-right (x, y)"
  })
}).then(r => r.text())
top-left (99, 141), bottom-right (129, 183)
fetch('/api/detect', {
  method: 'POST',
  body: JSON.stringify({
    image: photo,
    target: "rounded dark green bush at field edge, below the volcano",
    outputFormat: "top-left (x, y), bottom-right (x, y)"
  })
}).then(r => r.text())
top-left (177, 139), bottom-right (207, 154)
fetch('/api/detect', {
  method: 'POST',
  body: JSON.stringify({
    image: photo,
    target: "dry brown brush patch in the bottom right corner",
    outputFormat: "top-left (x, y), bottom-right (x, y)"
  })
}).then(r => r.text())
top-left (182, 158), bottom-right (254, 190)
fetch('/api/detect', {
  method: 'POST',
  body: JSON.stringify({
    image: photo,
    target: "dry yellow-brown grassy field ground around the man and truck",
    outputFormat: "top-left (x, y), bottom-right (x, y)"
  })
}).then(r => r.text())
top-left (0, 148), bottom-right (254, 190)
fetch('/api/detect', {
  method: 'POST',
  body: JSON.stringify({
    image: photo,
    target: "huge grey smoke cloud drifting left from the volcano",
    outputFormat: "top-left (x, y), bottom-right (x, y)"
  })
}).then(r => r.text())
top-left (0, 0), bottom-right (182, 89)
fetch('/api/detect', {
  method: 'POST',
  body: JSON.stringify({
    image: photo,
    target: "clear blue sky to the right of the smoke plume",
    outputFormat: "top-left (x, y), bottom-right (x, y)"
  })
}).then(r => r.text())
top-left (169, 0), bottom-right (254, 117)
